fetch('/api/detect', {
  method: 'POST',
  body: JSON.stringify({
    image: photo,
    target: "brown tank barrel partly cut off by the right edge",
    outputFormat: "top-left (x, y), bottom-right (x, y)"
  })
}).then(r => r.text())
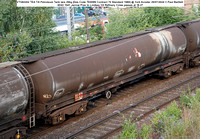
top-left (181, 20), bottom-right (200, 52)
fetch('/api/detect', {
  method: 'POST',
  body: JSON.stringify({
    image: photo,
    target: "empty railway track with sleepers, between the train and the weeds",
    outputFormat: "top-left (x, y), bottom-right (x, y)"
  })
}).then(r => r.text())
top-left (66, 74), bottom-right (200, 139)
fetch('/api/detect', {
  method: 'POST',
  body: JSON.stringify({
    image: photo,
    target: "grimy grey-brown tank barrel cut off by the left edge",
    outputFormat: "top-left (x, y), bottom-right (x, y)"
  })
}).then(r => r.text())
top-left (0, 67), bottom-right (29, 120)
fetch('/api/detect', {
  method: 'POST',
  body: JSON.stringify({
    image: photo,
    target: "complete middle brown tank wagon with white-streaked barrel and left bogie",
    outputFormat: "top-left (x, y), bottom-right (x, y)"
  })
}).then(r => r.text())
top-left (19, 25), bottom-right (186, 124)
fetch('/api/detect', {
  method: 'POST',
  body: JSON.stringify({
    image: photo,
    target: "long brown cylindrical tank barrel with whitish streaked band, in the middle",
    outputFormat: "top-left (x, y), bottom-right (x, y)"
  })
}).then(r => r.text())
top-left (24, 27), bottom-right (186, 103)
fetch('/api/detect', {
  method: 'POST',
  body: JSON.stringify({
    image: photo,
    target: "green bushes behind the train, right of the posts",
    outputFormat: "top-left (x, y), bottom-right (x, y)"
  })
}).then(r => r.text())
top-left (105, 7), bottom-right (198, 38)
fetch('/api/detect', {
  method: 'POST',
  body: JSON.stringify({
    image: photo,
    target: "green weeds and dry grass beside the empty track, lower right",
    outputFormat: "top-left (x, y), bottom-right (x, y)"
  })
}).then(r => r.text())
top-left (120, 89), bottom-right (200, 139)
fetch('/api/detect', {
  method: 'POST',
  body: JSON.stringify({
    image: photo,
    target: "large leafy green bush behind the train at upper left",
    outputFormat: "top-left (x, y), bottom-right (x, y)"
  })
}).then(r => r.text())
top-left (0, 0), bottom-right (58, 61)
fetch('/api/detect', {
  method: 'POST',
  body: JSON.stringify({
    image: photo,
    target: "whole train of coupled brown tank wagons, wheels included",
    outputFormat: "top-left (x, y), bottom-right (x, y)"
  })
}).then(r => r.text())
top-left (0, 19), bottom-right (200, 138)
